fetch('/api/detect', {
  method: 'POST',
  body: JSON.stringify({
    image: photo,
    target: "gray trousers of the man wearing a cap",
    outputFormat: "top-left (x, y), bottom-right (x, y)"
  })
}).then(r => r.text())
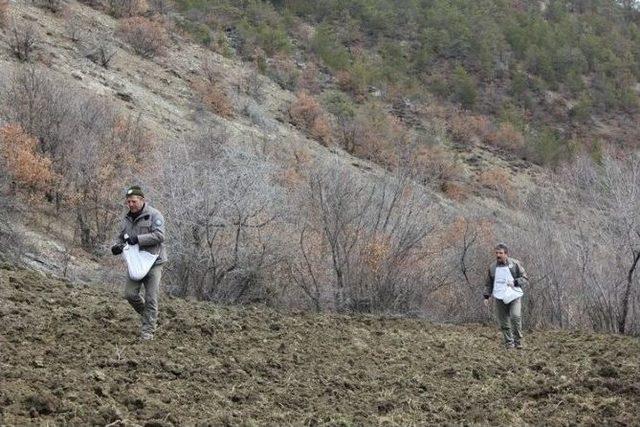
top-left (124, 265), bottom-right (162, 334)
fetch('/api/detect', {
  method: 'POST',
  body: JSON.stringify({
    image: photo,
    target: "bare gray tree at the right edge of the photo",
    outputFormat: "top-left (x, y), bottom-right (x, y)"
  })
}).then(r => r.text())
top-left (568, 156), bottom-right (640, 333)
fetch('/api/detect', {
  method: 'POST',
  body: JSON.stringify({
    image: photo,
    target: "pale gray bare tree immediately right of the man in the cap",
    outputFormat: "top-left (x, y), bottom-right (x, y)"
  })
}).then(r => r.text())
top-left (164, 129), bottom-right (280, 303)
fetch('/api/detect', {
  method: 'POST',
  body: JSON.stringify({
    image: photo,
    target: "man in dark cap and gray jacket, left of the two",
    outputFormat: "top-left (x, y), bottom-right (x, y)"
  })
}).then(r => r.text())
top-left (111, 186), bottom-right (167, 340)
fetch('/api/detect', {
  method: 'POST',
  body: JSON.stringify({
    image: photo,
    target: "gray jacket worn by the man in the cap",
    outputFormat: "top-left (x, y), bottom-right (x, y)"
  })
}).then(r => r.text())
top-left (117, 203), bottom-right (167, 264)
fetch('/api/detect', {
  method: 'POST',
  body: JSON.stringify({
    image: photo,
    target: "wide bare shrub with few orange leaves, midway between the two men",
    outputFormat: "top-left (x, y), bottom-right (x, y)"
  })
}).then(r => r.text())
top-left (289, 164), bottom-right (436, 312)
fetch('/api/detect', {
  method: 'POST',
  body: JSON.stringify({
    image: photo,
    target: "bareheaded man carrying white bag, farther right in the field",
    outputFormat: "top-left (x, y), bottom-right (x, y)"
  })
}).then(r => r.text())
top-left (484, 243), bottom-right (529, 348)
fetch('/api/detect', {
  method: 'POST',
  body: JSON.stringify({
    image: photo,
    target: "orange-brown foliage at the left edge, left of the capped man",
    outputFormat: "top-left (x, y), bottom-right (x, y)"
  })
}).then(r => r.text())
top-left (0, 124), bottom-right (54, 193)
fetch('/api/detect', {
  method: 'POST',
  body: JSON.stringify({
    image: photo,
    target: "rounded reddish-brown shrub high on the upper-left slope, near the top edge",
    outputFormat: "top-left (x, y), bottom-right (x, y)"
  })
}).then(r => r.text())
top-left (119, 16), bottom-right (168, 58)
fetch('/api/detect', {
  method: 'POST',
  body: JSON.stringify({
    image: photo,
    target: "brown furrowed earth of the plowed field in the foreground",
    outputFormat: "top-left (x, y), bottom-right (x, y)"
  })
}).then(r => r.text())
top-left (0, 266), bottom-right (640, 426)
